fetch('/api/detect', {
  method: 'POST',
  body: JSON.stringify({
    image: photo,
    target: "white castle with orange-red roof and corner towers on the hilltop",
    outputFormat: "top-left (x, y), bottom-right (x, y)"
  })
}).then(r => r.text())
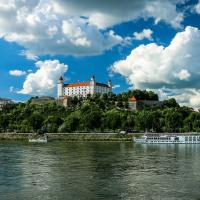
top-left (57, 76), bottom-right (112, 98)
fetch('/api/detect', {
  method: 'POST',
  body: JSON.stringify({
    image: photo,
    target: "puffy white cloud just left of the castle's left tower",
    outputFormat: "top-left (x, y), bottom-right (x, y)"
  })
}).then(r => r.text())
top-left (18, 60), bottom-right (68, 95)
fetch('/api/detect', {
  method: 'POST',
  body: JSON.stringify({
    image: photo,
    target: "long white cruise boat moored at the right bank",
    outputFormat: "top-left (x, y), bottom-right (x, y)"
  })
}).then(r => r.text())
top-left (133, 134), bottom-right (200, 144)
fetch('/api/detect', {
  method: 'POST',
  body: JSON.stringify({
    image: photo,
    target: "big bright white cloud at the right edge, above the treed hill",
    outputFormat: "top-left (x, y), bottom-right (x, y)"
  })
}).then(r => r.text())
top-left (111, 26), bottom-right (200, 108)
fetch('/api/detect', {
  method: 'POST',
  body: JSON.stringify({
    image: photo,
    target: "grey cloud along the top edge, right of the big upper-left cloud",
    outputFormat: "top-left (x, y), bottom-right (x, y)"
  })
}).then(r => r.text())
top-left (54, 0), bottom-right (183, 29)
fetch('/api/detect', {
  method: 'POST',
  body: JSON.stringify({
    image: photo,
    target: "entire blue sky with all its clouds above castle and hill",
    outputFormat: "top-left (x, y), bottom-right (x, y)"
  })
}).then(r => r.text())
top-left (0, 0), bottom-right (200, 108)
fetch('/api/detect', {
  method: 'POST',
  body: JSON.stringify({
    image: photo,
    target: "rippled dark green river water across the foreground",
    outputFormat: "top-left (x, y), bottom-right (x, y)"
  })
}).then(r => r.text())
top-left (0, 142), bottom-right (200, 200)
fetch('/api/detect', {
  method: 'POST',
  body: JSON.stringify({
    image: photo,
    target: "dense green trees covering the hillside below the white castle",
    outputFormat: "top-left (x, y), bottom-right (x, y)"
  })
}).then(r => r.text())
top-left (0, 90), bottom-right (200, 133)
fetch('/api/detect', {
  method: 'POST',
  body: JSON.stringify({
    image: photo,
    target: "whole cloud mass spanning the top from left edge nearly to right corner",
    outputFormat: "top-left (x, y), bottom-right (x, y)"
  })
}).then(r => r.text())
top-left (0, 0), bottom-right (183, 56)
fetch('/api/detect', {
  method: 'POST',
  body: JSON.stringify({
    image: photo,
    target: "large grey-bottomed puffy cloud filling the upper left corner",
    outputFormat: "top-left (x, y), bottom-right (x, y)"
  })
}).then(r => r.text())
top-left (0, 0), bottom-right (123, 56)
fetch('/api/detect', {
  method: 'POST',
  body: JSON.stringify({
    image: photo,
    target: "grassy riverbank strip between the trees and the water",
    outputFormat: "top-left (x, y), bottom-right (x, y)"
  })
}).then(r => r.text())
top-left (0, 133), bottom-right (134, 142)
